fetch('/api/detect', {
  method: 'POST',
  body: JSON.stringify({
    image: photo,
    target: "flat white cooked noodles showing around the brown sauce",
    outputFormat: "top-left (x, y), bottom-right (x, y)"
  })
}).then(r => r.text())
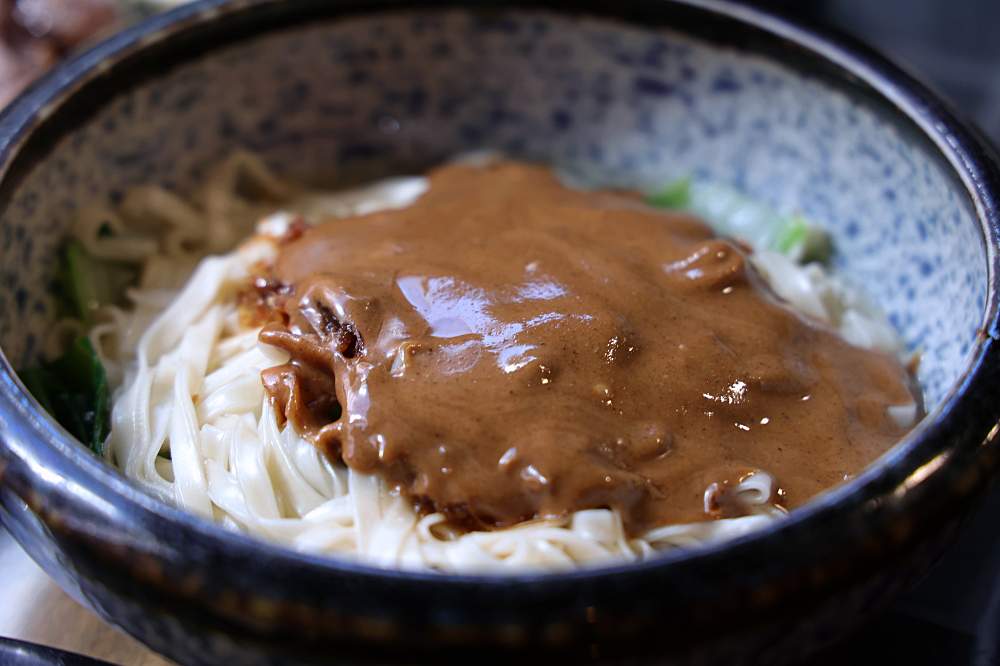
top-left (82, 154), bottom-right (916, 571)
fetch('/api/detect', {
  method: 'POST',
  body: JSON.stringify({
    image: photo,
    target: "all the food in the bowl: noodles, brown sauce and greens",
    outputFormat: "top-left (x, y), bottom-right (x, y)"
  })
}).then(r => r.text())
top-left (26, 154), bottom-right (921, 571)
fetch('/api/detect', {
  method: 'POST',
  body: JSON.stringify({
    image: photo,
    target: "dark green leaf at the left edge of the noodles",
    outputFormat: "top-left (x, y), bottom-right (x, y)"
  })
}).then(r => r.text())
top-left (20, 337), bottom-right (111, 455)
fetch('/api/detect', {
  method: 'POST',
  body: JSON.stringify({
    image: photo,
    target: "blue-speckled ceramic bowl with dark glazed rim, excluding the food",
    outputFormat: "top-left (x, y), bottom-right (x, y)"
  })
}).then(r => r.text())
top-left (0, 0), bottom-right (1000, 663)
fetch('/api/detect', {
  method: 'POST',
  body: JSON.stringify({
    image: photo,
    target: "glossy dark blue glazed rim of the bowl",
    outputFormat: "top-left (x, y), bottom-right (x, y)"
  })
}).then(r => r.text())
top-left (0, 0), bottom-right (1000, 591)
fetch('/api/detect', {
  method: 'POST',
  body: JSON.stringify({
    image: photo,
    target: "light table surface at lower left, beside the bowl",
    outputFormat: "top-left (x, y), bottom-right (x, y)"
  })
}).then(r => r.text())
top-left (0, 528), bottom-right (171, 666)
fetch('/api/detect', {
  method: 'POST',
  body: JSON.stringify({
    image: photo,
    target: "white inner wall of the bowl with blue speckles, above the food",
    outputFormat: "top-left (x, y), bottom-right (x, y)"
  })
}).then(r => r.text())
top-left (0, 10), bottom-right (987, 409)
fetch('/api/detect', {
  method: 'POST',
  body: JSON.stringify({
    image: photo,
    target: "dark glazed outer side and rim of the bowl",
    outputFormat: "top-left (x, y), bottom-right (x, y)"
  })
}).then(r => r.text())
top-left (0, 0), bottom-right (1000, 664)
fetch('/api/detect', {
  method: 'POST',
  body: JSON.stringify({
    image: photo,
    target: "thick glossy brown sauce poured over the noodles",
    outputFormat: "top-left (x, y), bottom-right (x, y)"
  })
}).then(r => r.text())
top-left (258, 162), bottom-right (914, 534)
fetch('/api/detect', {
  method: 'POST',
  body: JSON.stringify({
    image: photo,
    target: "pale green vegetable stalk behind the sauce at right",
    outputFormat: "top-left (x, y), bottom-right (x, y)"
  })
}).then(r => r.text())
top-left (646, 178), bottom-right (833, 262)
